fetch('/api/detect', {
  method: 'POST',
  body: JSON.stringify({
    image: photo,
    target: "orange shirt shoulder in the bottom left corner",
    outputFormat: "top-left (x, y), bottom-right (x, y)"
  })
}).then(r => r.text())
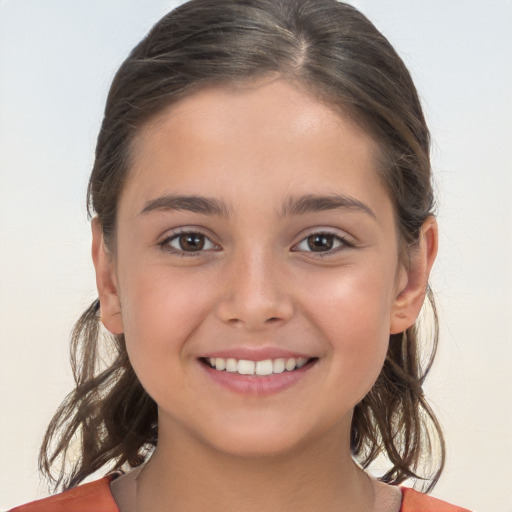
top-left (10, 477), bottom-right (119, 512)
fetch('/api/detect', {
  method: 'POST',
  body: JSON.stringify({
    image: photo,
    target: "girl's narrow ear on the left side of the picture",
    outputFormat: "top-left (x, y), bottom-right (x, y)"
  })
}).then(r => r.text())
top-left (91, 217), bottom-right (124, 334)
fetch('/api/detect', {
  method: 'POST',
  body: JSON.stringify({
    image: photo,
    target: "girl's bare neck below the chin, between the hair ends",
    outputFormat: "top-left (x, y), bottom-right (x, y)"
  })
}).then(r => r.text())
top-left (138, 420), bottom-right (374, 512)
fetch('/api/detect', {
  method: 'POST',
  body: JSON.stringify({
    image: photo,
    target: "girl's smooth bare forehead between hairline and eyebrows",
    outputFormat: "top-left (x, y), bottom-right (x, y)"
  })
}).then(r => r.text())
top-left (122, 80), bottom-right (390, 218)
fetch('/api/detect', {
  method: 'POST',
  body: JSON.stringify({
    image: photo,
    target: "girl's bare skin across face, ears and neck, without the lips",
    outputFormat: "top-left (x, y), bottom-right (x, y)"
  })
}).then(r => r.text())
top-left (93, 80), bottom-right (437, 512)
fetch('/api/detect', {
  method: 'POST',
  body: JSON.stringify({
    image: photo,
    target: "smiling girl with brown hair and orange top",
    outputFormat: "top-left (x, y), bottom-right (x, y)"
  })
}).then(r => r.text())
top-left (10, 0), bottom-right (472, 512)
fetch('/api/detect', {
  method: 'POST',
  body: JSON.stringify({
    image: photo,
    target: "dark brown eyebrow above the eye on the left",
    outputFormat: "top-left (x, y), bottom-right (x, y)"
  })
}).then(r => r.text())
top-left (139, 194), bottom-right (231, 217)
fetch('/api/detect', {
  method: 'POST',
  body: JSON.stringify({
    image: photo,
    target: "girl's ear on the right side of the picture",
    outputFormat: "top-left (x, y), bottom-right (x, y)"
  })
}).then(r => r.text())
top-left (389, 216), bottom-right (439, 334)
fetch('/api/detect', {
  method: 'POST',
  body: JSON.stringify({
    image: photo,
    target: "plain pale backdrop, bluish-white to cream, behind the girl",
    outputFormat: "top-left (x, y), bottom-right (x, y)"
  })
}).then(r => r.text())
top-left (0, 0), bottom-right (512, 512)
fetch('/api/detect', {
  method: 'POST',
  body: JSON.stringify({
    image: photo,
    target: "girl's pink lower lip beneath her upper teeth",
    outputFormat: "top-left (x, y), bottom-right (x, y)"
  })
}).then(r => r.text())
top-left (200, 360), bottom-right (316, 396)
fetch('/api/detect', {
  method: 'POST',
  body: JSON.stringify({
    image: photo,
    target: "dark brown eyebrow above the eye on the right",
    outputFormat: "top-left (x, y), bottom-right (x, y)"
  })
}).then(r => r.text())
top-left (279, 194), bottom-right (377, 219)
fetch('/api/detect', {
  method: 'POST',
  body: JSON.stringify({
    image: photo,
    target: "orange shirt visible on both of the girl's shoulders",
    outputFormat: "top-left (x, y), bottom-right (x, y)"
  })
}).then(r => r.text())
top-left (10, 476), bottom-right (469, 512)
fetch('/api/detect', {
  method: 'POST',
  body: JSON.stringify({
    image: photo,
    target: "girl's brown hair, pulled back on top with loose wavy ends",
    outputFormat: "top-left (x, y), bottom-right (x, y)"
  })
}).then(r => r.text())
top-left (40, 0), bottom-right (444, 489)
